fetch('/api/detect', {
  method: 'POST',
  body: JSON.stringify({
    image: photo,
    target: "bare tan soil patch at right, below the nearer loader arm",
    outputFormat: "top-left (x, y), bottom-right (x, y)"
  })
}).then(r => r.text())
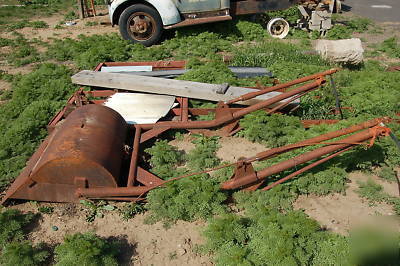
top-left (294, 172), bottom-right (400, 235)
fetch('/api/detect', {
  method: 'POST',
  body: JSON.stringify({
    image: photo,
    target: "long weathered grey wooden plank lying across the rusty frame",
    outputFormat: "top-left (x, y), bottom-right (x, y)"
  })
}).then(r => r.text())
top-left (72, 70), bottom-right (296, 105)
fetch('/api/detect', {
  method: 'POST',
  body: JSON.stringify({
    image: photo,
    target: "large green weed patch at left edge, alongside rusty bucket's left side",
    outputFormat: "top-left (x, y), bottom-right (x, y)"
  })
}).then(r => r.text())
top-left (0, 64), bottom-right (74, 190)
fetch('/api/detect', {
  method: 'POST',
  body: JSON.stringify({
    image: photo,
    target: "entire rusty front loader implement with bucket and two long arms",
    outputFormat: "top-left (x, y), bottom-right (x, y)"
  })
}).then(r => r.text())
top-left (2, 66), bottom-right (390, 204)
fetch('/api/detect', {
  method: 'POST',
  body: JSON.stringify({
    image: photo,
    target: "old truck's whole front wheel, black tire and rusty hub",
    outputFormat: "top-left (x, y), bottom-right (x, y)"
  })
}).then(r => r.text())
top-left (118, 4), bottom-right (163, 46)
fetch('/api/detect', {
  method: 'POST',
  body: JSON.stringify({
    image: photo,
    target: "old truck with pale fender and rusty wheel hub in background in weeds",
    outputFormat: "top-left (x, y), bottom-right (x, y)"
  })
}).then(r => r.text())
top-left (108, 0), bottom-right (340, 46)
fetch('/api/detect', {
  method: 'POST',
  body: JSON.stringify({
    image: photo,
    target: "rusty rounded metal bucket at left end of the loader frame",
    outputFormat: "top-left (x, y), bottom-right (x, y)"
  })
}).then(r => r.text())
top-left (3, 104), bottom-right (128, 203)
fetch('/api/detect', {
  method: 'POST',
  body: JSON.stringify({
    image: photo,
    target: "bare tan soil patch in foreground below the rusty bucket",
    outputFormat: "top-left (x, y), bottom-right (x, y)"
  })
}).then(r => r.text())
top-left (13, 202), bottom-right (212, 265)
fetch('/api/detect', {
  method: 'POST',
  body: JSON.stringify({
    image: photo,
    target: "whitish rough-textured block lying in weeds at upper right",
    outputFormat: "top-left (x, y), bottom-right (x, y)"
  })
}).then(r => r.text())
top-left (315, 38), bottom-right (364, 65)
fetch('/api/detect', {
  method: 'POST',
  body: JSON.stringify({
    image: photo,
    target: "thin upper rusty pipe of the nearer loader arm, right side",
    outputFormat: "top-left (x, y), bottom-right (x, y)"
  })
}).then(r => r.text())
top-left (249, 117), bottom-right (390, 161)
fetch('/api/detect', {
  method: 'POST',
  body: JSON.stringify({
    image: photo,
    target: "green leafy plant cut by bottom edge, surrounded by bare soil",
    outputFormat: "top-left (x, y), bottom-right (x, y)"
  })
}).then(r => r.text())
top-left (54, 233), bottom-right (119, 266)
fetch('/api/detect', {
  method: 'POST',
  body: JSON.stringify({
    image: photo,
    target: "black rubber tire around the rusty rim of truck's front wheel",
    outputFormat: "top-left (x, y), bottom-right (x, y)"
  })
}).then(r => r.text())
top-left (118, 4), bottom-right (164, 46)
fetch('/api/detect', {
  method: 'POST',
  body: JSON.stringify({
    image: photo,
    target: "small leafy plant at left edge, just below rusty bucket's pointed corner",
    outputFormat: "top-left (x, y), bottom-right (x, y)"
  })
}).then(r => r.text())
top-left (0, 209), bottom-right (34, 248)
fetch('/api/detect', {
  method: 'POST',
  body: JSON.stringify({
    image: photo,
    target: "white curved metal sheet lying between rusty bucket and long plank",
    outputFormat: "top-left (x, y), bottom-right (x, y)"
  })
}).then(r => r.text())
top-left (104, 93), bottom-right (175, 124)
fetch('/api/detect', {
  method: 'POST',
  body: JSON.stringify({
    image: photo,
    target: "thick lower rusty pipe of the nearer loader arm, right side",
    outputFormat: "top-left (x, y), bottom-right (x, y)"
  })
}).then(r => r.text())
top-left (221, 128), bottom-right (387, 190)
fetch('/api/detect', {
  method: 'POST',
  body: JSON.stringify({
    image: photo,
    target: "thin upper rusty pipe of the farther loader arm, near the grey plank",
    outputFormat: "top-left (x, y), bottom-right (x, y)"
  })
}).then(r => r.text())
top-left (226, 68), bottom-right (339, 104)
